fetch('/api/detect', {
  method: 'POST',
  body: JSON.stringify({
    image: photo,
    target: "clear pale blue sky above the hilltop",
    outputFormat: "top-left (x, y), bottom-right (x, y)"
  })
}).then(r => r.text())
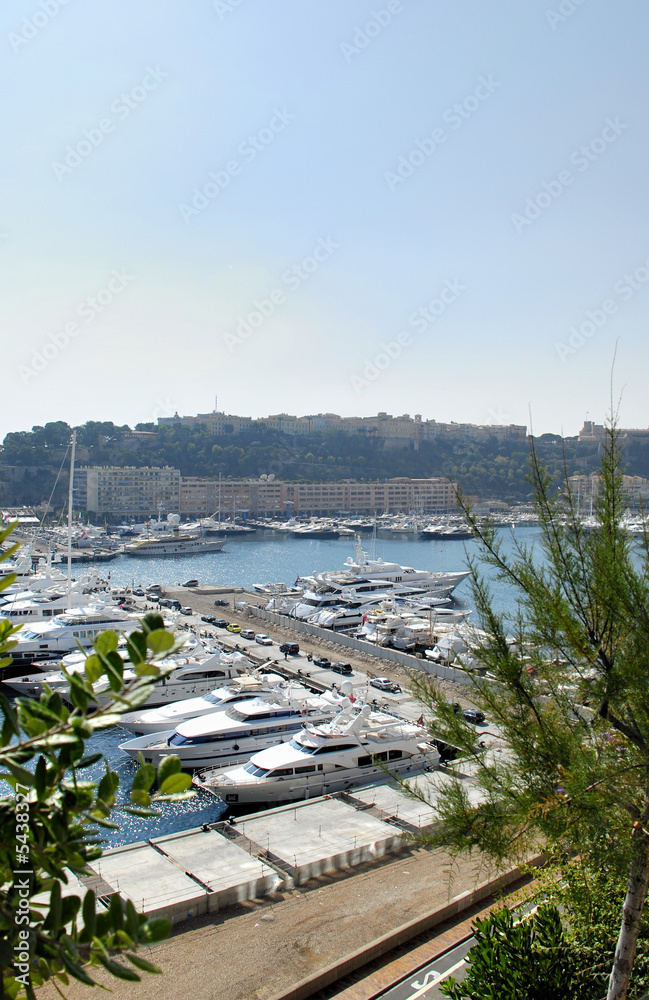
top-left (0, 0), bottom-right (649, 435)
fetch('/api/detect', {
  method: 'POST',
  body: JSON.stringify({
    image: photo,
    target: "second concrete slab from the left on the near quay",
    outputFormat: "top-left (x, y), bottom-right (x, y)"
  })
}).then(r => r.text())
top-left (151, 830), bottom-right (282, 913)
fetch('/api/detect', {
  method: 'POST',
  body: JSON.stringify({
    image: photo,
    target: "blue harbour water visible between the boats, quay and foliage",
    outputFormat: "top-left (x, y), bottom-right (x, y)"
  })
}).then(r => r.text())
top-left (6, 527), bottom-right (539, 847)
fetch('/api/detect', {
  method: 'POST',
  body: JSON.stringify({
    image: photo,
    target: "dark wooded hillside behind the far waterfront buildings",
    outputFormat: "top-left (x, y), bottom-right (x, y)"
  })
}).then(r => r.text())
top-left (0, 420), bottom-right (649, 505)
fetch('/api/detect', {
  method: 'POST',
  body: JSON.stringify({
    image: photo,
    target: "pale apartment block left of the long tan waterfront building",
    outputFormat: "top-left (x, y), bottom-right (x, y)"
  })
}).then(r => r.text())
top-left (74, 465), bottom-right (180, 518)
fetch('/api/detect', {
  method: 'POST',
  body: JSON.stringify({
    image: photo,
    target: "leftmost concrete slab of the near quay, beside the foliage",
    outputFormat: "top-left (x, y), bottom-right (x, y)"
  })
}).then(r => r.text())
top-left (92, 842), bottom-right (207, 922)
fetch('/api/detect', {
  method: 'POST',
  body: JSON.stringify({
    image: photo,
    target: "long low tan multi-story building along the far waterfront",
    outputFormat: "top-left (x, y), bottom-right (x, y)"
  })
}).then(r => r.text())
top-left (179, 477), bottom-right (456, 517)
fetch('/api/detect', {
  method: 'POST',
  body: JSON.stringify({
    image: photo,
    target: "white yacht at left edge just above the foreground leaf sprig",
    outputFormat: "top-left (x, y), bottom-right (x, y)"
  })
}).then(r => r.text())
top-left (5, 605), bottom-right (140, 674)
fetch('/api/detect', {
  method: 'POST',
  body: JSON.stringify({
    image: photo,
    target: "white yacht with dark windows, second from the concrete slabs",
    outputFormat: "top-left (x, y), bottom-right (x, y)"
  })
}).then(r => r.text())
top-left (120, 692), bottom-right (349, 771)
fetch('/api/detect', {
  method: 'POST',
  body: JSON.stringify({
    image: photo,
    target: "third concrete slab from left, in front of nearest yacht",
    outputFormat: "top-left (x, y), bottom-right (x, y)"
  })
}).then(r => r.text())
top-left (236, 798), bottom-right (403, 885)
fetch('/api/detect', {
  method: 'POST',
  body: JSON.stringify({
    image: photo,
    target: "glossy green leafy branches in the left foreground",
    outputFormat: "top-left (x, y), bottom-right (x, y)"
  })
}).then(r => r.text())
top-left (0, 531), bottom-right (191, 1000)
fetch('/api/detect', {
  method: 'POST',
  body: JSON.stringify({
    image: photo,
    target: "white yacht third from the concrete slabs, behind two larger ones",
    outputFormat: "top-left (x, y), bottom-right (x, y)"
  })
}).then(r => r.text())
top-left (120, 671), bottom-right (294, 736)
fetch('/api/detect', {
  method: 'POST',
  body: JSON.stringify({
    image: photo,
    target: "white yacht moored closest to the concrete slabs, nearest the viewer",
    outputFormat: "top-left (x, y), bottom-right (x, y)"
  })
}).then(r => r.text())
top-left (193, 705), bottom-right (439, 805)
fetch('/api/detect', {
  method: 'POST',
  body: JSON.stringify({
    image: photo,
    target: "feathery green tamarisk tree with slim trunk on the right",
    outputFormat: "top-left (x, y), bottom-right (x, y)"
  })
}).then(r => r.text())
top-left (413, 423), bottom-right (649, 1000)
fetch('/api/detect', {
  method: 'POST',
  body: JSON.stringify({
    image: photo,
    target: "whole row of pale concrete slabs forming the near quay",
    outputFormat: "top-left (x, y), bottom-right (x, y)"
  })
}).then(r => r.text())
top-left (81, 770), bottom-right (474, 924)
